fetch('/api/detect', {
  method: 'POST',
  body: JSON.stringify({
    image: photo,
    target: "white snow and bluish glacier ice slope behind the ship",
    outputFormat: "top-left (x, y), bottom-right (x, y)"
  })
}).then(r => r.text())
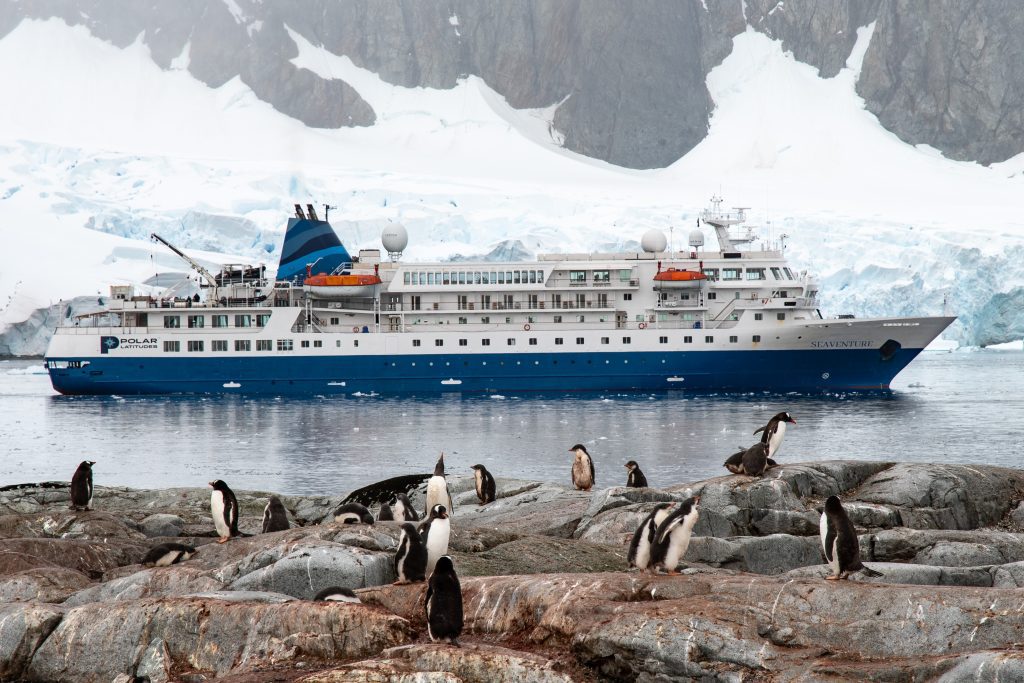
top-left (0, 19), bottom-right (1024, 353)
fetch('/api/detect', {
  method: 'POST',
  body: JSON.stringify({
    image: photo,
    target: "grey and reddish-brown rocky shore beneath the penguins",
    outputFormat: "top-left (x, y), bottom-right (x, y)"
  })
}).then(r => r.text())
top-left (0, 461), bottom-right (1024, 683)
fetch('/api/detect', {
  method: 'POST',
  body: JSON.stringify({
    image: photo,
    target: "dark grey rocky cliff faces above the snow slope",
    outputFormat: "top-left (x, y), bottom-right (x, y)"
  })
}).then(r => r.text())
top-left (0, 0), bottom-right (1024, 168)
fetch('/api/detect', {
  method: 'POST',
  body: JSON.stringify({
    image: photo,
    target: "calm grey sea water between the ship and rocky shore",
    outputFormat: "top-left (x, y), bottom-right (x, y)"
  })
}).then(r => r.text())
top-left (0, 351), bottom-right (1024, 495)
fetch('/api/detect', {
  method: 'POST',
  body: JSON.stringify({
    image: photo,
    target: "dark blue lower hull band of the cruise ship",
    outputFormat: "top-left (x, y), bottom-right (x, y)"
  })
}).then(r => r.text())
top-left (47, 348), bottom-right (922, 395)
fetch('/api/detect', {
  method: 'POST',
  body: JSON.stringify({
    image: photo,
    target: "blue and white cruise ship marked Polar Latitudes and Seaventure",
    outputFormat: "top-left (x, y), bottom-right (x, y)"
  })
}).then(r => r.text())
top-left (46, 198), bottom-right (955, 396)
